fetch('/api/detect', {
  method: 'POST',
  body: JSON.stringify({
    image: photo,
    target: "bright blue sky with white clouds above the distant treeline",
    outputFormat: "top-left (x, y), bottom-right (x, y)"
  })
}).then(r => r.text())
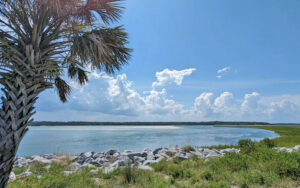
top-left (35, 0), bottom-right (300, 122)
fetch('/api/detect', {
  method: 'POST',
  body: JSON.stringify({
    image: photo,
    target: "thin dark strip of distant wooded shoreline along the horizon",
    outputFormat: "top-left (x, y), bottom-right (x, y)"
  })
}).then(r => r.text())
top-left (30, 121), bottom-right (300, 126)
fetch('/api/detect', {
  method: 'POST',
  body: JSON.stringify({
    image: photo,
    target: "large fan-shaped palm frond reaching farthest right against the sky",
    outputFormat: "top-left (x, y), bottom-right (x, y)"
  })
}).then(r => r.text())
top-left (71, 26), bottom-right (132, 73)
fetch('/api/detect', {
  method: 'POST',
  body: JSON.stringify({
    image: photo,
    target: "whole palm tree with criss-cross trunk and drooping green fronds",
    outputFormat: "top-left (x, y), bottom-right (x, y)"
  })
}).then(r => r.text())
top-left (0, 0), bottom-right (131, 188)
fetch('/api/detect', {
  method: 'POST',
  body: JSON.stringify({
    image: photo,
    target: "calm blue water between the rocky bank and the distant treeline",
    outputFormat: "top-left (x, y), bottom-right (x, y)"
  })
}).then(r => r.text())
top-left (18, 126), bottom-right (278, 156)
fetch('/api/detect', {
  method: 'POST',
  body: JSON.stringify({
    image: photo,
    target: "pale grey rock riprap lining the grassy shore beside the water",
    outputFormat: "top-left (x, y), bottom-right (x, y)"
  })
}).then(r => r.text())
top-left (10, 146), bottom-right (300, 182)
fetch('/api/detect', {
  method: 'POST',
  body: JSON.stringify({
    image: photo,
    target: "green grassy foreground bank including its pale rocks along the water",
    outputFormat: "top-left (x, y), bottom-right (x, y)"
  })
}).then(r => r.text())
top-left (8, 126), bottom-right (300, 188)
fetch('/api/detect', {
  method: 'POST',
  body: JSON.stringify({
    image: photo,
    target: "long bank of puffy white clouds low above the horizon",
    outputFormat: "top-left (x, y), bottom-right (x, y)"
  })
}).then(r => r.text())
top-left (35, 68), bottom-right (300, 122)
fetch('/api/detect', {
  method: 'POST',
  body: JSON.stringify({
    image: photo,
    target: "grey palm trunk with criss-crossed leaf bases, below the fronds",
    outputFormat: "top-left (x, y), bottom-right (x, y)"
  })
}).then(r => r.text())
top-left (0, 76), bottom-right (45, 188)
